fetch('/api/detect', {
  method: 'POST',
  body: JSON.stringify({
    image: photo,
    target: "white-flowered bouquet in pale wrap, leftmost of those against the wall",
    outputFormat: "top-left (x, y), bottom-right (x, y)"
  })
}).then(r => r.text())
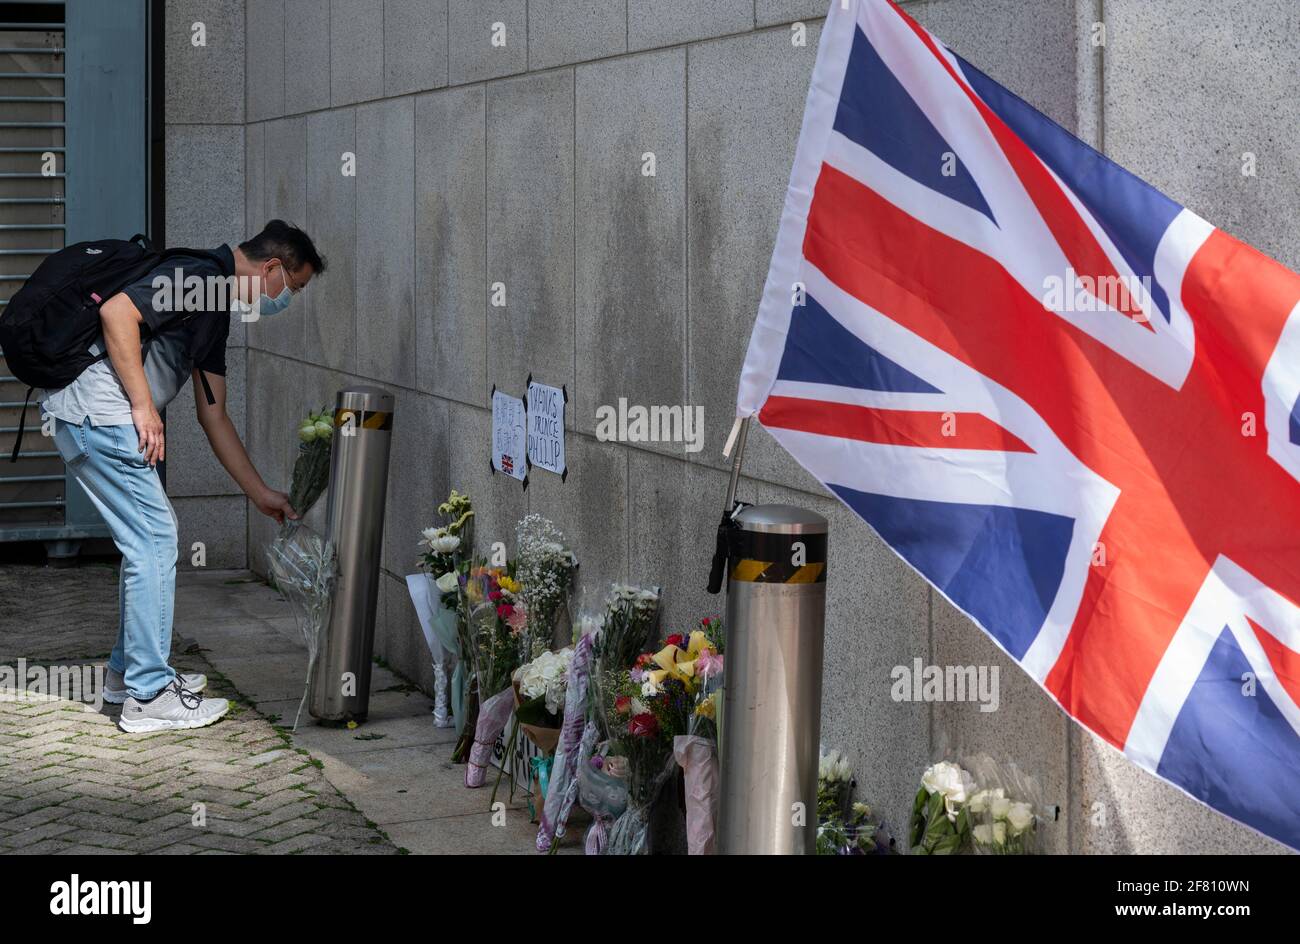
top-left (412, 489), bottom-right (475, 733)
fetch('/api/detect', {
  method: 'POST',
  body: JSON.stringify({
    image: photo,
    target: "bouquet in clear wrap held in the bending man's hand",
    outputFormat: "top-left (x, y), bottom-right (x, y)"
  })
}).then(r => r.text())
top-left (267, 410), bottom-right (337, 729)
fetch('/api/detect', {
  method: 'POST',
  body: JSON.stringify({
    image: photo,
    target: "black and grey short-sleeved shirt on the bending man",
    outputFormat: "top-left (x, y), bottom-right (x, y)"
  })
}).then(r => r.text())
top-left (122, 244), bottom-right (235, 408)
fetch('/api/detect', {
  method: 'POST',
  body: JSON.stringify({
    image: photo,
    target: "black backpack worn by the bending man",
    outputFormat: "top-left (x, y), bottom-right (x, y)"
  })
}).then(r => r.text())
top-left (0, 234), bottom-right (222, 460)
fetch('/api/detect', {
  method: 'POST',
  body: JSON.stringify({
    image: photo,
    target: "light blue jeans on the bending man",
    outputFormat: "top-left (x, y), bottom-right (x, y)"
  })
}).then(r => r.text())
top-left (55, 417), bottom-right (177, 700)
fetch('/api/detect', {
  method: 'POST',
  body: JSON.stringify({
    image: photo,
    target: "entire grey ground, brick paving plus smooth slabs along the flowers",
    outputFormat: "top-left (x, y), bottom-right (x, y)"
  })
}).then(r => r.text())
top-left (0, 563), bottom-right (569, 854)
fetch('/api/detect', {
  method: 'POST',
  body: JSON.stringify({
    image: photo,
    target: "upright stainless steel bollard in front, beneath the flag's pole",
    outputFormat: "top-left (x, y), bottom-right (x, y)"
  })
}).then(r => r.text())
top-left (719, 505), bottom-right (827, 856)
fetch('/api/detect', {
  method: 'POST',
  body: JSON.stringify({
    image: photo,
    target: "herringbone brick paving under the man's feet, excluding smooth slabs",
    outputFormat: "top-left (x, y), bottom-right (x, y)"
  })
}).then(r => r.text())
top-left (0, 563), bottom-right (398, 854)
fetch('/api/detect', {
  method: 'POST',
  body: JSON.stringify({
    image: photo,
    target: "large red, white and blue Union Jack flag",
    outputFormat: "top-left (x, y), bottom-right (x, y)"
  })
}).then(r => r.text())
top-left (737, 0), bottom-right (1300, 848)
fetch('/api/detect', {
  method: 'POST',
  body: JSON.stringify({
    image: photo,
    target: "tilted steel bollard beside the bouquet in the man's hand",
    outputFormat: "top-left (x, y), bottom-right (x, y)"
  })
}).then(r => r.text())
top-left (307, 386), bottom-right (393, 722)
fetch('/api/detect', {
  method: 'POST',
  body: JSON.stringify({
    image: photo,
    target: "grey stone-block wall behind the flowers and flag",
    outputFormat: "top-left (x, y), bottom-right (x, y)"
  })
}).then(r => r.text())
top-left (168, 0), bottom-right (1300, 852)
